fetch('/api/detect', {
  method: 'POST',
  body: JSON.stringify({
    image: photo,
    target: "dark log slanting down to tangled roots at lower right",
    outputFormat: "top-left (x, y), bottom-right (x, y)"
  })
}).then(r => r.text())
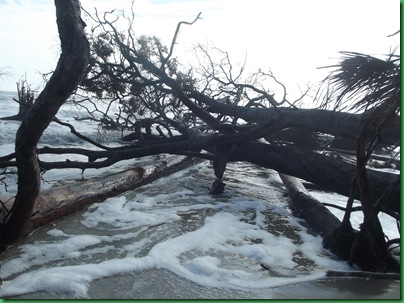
top-left (279, 174), bottom-right (400, 272)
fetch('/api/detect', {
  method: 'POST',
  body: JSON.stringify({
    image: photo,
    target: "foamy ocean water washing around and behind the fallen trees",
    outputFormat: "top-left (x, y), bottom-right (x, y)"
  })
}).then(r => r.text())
top-left (0, 92), bottom-right (398, 299)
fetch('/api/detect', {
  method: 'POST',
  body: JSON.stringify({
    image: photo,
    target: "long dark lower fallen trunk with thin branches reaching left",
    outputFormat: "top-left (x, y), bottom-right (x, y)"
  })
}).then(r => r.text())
top-left (4, 132), bottom-right (400, 213)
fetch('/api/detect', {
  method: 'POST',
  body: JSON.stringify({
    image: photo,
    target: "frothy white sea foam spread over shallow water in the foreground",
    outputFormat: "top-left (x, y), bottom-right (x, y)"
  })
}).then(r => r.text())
top-left (0, 191), bottom-right (354, 298)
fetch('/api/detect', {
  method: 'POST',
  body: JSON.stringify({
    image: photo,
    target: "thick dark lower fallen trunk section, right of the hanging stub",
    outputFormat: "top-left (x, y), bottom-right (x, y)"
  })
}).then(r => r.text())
top-left (230, 142), bottom-right (400, 213)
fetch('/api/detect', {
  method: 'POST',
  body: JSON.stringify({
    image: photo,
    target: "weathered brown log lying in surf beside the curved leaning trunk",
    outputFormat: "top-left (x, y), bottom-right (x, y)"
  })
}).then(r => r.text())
top-left (1, 156), bottom-right (197, 240)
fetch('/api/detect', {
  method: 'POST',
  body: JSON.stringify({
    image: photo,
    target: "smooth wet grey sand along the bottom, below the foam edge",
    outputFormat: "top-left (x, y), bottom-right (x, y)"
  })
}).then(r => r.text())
top-left (13, 269), bottom-right (401, 300)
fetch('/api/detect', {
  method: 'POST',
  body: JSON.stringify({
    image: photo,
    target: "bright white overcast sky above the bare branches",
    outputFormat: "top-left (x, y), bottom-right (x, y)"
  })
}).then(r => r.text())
top-left (0, 0), bottom-right (400, 101)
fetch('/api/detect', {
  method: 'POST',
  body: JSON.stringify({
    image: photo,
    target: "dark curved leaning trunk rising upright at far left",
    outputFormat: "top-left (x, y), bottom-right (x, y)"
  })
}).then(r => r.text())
top-left (0, 0), bottom-right (89, 245)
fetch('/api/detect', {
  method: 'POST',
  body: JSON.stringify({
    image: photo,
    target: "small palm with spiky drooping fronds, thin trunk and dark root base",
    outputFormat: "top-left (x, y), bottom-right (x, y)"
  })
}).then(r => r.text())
top-left (321, 48), bottom-right (400, 271)
